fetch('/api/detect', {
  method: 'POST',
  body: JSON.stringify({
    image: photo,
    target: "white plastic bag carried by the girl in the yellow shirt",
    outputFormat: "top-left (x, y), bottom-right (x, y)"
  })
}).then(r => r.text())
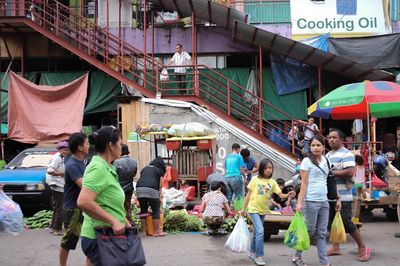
top-left (225, 216), bottom-right (250, 252)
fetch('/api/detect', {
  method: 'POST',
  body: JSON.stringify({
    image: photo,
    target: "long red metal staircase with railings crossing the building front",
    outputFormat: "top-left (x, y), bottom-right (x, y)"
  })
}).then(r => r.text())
top-left (0, 0), bottom-right (304, 158)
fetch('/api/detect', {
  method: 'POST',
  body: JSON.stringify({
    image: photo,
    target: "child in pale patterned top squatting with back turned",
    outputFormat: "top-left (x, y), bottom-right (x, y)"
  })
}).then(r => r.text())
top-left (200, 181), bottom-right (231, 234)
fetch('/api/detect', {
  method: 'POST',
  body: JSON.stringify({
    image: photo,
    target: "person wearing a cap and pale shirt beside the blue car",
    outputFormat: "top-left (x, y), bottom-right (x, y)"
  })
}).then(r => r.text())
top-left (46, 141), bottom-right (69, 235)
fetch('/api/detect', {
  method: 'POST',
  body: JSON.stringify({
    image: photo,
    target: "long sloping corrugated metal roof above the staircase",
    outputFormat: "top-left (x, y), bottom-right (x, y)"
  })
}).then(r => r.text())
top-left (149, 0), bottom-right (394, 80)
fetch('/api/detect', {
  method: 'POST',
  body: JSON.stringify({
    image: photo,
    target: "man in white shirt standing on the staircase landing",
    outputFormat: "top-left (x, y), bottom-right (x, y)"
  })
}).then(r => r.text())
top-left (167, 43), bottom-right (192, 94)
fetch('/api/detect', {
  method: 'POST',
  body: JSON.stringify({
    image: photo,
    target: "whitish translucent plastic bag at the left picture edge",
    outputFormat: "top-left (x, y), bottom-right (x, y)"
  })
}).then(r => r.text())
top-left (0, 190), bottom-right (24, 235)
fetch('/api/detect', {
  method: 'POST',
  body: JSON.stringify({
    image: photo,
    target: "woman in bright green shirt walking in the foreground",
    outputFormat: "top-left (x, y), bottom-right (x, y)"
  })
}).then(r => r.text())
top-left (78, 126), bottom-right (130, 265)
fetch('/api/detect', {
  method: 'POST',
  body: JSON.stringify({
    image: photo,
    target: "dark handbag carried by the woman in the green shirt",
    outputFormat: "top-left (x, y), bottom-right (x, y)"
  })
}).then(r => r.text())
top-left (94, 227), bottom-right (146, 266)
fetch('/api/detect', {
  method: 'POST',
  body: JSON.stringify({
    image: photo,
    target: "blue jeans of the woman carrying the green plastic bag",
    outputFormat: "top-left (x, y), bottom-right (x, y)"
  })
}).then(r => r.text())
top-left (296, 201), bottom-right (329, 265)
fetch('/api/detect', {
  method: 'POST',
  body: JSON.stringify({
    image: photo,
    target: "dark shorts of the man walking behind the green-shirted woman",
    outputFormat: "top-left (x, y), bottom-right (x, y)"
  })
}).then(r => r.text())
top-left (61, 208), bottom-right (83, 250)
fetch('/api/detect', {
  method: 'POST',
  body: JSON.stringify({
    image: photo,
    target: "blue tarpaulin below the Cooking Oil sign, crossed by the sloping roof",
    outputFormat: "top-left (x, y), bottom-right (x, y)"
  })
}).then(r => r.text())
top-left (270, 34), bottom-right (329, 95)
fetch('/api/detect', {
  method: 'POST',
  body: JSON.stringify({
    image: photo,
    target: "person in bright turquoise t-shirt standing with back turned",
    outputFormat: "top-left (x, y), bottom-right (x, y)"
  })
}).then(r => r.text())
top-left (225, 143), bottom-right (246, 204)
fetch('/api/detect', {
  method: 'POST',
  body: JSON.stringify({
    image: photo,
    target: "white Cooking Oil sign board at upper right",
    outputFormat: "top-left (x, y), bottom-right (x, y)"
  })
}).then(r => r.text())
top-left (290, 0), bottom-right (391, 40)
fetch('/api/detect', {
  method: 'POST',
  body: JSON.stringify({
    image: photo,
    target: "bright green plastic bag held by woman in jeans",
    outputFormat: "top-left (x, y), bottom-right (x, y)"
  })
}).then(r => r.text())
top-left (283, 212), bottom-right (310, 251)
